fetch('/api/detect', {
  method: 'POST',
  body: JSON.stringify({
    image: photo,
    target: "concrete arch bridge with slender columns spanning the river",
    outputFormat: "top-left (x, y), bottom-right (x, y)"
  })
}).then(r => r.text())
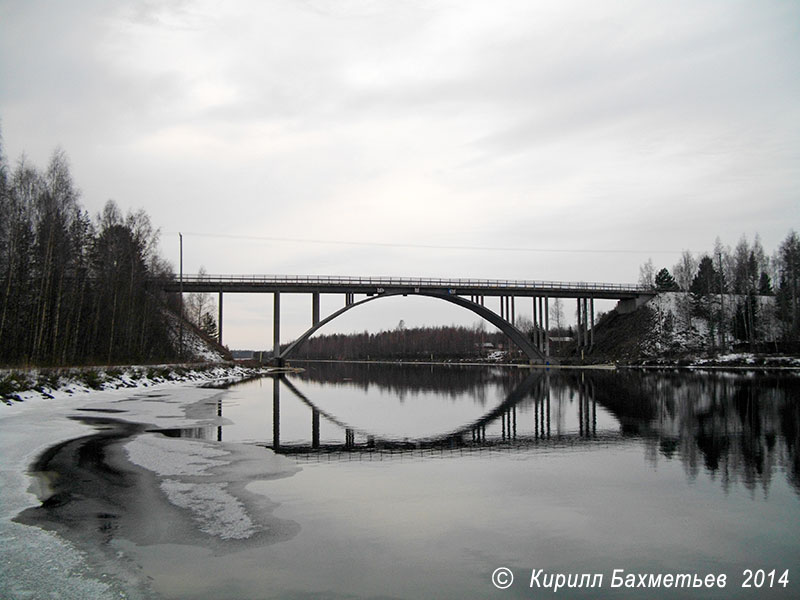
top-left (153, 275), bottom-right (654, 364)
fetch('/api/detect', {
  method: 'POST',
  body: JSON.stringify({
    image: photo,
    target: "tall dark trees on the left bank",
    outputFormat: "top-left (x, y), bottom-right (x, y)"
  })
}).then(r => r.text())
top-left (0, 145), bottom-right (183, 366)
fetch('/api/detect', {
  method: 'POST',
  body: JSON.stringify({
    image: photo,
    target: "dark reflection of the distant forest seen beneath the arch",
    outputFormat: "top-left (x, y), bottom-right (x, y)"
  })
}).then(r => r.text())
top-left (293, 362), bottom-right (528, 405)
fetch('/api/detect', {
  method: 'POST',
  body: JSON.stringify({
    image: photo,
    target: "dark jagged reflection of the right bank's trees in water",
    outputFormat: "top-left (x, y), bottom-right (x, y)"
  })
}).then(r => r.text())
top-left (592, 372), bottom-right (800, 493)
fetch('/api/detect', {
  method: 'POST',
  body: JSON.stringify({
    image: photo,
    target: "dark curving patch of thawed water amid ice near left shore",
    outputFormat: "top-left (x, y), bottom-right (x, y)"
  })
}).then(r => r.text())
top-left (14, 416), bottom-right (300, 598)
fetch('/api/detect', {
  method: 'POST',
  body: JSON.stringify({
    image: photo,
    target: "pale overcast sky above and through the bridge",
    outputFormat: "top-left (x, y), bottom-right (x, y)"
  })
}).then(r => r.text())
top-left (0, 0), bottom-right (800, 348)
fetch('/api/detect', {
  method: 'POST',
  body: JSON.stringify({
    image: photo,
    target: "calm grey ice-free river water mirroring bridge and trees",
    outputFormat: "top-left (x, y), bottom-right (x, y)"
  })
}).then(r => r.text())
top-left (152, 363), bottom-right (800, 599)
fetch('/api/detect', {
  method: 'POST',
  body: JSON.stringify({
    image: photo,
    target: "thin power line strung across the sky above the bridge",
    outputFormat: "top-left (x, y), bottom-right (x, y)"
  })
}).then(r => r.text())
top-left (166, 231), bottom-right (683, 254)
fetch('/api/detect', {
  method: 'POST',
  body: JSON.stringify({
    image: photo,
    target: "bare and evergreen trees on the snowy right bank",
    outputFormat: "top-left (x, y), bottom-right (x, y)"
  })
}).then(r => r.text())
top-left (639, 230), bottom-right (800, 347)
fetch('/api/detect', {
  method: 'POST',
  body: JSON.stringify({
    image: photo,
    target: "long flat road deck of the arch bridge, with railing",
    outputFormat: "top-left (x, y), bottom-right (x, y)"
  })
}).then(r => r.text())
top-left (153, 275), bottom-right (653, 300)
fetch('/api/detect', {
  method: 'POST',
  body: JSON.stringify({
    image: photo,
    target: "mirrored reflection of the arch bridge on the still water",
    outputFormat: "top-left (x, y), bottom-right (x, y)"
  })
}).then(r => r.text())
top-left (268, 371), bottom-right (604, 457)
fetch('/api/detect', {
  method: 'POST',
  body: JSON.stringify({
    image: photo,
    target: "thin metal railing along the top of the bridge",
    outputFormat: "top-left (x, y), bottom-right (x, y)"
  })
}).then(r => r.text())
top-left (161, 275), bottom-right (652, 293)
